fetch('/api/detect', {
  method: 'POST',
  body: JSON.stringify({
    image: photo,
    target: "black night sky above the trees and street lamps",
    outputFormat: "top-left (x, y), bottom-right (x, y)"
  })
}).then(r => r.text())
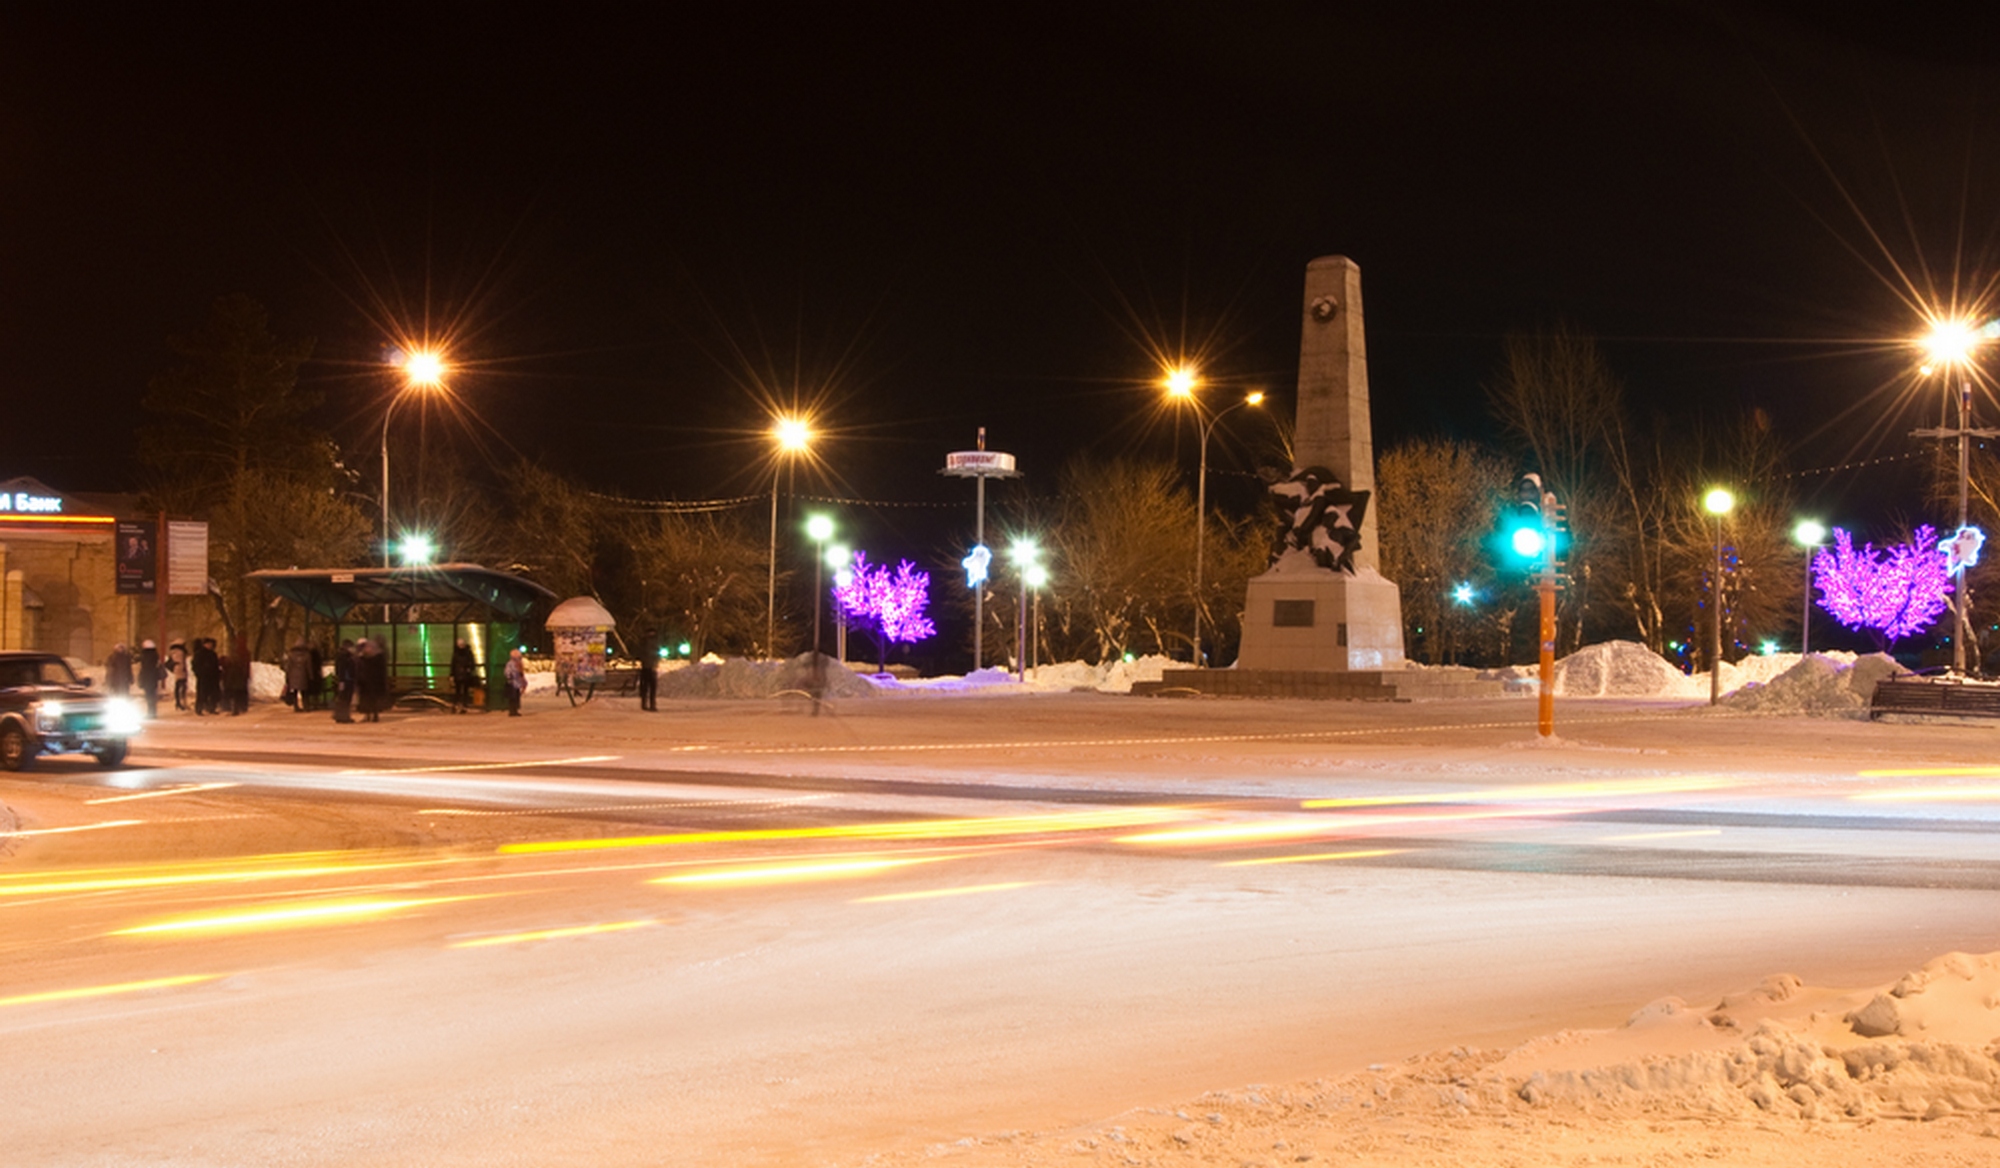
top-left (0, 4), bottom-right (2000, 552)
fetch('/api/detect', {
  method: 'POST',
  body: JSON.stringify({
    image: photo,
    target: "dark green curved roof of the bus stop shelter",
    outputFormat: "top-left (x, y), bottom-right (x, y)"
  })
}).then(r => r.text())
top-left (250, 564), bottom-right (556, 622)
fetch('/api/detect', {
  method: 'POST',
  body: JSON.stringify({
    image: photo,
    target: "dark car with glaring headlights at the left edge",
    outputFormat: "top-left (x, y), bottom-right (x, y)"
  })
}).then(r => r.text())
top-left (0, 652), bottom-right (140, 770)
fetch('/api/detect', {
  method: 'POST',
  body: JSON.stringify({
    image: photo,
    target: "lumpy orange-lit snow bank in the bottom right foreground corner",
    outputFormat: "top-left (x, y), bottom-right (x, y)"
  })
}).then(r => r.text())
top-left (1488, 954), bottom-right (2000, 1120)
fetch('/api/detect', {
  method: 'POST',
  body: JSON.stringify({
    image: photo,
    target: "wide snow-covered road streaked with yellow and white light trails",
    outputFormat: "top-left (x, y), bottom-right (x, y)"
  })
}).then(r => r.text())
top-left (0, 696), bottom-right (2000, 1164)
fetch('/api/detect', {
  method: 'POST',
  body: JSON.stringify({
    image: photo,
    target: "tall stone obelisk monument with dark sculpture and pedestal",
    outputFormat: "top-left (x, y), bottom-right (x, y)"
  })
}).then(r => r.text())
top-left (1236, 256), bottom-right (1404, 672)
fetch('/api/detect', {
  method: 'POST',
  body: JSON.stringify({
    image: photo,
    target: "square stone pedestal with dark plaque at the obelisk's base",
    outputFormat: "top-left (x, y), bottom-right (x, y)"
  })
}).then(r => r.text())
top-left (1236, 556), bottom-right (1404, 672)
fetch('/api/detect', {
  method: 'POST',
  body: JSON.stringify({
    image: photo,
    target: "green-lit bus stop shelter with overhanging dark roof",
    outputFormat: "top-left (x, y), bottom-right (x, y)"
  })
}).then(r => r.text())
top-left (250, 564), bottom-right (556, 708)
